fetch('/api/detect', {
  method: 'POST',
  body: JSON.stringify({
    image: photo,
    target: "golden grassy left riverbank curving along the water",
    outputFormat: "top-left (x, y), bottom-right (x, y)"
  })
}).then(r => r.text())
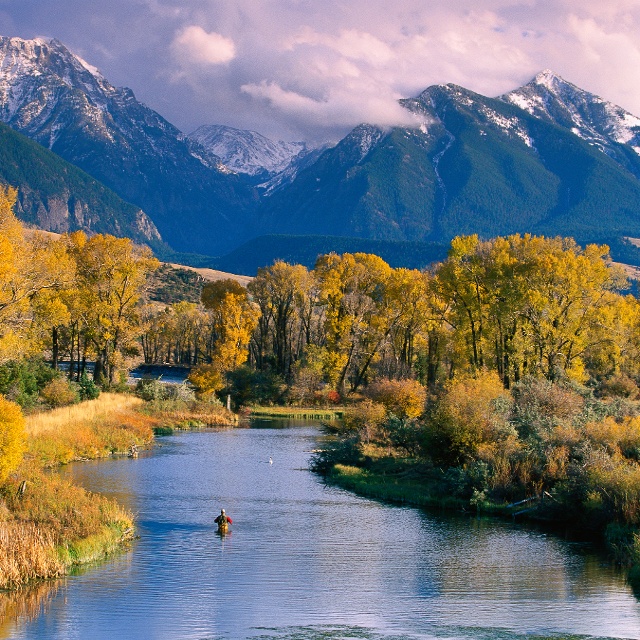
top-left (0, 393), bottom-right (237, 589)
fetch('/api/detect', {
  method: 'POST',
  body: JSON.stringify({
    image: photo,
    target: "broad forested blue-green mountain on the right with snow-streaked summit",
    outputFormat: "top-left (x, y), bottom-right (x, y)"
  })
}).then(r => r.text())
top-left (260, 74), bottom-right (640, 241)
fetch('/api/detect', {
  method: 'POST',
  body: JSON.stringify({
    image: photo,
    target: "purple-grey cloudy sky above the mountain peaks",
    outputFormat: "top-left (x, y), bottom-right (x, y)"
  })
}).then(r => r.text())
top-left (0, 0), bottom-right (640, 143)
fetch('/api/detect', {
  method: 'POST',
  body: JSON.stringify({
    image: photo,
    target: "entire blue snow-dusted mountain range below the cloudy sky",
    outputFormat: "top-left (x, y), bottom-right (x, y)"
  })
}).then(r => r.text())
top-left (0, 34), bottom-right (640, 272)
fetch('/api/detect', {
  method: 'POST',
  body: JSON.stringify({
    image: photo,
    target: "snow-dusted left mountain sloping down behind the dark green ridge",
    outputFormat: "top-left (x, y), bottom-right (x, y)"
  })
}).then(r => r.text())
top-left (0, 37), bottom-right (256, 254)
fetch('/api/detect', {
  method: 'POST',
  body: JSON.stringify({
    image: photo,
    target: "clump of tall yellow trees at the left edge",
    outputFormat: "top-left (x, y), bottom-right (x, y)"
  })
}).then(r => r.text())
top-left (0, 188), bottom-right (159, 393)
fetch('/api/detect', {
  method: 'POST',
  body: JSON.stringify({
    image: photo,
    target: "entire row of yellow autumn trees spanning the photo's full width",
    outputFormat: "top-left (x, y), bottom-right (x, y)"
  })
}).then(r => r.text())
top-left (0, 175), bottom-right (640, 402)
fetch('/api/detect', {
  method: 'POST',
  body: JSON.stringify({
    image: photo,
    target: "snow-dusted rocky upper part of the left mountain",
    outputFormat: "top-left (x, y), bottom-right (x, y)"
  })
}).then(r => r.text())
top-left (0, 37), bottom-right (228, 169)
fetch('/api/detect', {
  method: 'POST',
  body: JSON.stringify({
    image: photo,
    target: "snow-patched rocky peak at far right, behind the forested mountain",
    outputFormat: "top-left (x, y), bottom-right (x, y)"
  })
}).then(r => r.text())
top-left (500, 69), bottom-right (640, 156)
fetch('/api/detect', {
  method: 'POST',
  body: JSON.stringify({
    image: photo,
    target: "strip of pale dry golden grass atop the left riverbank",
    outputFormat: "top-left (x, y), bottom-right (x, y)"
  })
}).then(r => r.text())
top-left (25, 393), bottom-right (144, 436)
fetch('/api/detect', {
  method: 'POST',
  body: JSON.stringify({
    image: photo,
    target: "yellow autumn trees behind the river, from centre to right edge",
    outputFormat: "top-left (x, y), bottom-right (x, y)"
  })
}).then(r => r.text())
top-left (141, 235), bottom-right (640, 402)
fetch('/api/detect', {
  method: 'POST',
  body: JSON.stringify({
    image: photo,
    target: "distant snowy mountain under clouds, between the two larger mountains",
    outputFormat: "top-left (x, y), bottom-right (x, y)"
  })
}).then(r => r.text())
top-left (189, 125), bottom-right (309, 179)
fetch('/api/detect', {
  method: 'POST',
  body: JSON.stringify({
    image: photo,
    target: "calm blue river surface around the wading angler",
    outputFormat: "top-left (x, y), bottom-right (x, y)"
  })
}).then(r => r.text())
top-left (0, 422), bottom-right (640, 640)
